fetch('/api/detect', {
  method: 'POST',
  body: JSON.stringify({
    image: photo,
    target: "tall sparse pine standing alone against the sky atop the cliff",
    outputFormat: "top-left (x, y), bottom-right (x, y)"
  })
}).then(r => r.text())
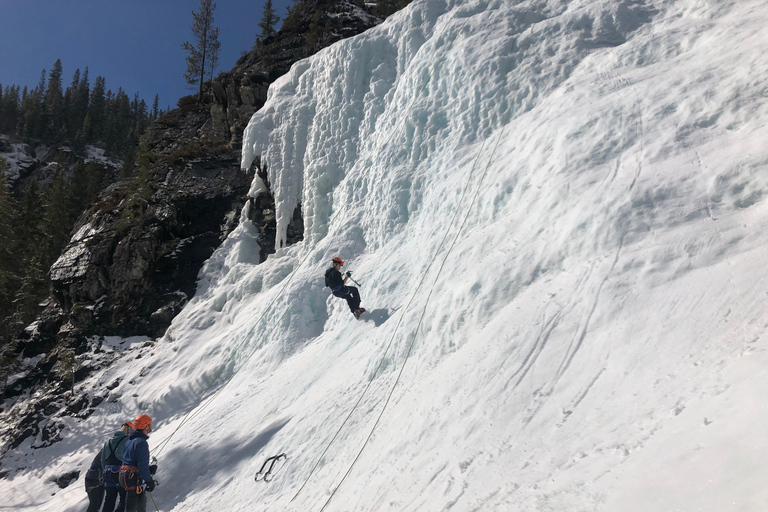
top-left (181, 0), bottom-right (221, 101)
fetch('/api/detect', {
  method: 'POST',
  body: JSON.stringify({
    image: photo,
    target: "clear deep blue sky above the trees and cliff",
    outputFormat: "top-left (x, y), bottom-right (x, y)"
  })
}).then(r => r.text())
top-left (0, 0), bottom-right (293, 108)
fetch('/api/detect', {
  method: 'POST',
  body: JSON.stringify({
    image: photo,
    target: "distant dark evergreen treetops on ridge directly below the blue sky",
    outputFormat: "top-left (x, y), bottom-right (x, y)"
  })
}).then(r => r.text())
top-left (0, 60), bottom-right (162, 156)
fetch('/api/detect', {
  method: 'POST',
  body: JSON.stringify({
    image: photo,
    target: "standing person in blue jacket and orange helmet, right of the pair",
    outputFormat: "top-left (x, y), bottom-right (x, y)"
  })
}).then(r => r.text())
top-left (120, 414), bottom-right (156, 512)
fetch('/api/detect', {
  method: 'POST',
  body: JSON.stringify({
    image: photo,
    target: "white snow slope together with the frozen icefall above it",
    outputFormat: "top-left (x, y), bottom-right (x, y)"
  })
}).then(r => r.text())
top-left (0, 0), bottom-right (768, 512)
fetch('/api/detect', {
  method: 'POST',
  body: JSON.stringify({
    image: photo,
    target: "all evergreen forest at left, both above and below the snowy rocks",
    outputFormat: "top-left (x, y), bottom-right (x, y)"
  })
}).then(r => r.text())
top-left (0, 60), bottom-right (164, 348)
